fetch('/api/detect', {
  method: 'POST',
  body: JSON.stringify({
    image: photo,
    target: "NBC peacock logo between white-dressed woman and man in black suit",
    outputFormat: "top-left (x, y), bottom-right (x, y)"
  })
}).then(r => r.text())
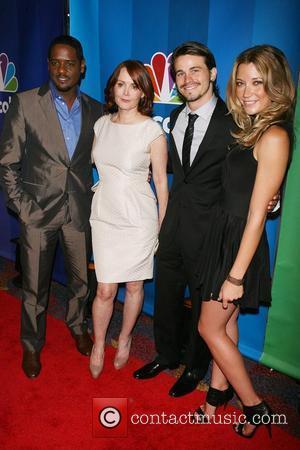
top-left (145, 52), bottom-right (182, 105)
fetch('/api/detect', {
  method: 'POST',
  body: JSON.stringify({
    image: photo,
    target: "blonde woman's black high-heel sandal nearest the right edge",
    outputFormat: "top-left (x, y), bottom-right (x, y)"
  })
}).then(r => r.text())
top-left (233, 402), bottom-right (272, 439)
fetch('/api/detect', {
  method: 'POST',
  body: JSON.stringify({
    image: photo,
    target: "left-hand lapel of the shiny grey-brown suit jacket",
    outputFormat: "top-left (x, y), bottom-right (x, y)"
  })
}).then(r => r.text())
top-left (39, 86), bottom-right (70, 165)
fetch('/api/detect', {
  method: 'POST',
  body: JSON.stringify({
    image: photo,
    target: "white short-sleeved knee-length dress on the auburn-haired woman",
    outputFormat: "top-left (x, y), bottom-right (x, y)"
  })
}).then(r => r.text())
top-left (90, 115), bottom-right (163, 283)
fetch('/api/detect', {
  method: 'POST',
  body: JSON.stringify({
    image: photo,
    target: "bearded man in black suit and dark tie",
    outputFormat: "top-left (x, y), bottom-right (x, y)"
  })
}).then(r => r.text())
top-left (134, 41), bottom-right (234, 397)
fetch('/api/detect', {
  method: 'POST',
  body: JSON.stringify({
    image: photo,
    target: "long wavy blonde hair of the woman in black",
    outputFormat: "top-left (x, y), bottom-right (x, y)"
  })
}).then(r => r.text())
top-left (227, 45), bottom-right (295, 147)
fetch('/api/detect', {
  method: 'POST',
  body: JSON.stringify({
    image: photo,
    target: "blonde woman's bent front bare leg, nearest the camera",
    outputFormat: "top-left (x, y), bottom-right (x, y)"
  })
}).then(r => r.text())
top-left (199, 301), bottom-right (261, 434)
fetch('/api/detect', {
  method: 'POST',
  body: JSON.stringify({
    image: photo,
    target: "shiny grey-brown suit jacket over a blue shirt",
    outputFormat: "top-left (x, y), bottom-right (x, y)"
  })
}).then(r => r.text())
top-left (0, 84), bottom-right (103, 230)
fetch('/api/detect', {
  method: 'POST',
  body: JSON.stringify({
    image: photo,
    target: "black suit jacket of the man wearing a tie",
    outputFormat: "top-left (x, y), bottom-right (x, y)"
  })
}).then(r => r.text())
top-left (160, 98), bottom-right (236, 253)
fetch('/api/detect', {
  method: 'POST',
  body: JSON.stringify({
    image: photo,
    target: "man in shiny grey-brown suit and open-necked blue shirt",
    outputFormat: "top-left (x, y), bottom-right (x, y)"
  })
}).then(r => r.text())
top-left (0, 36), bottom-right (103, 378)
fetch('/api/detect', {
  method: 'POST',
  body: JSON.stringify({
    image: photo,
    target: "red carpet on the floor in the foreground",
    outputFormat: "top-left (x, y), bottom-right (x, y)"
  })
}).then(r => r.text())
top-left (0, 292), bottom-right (299, 450)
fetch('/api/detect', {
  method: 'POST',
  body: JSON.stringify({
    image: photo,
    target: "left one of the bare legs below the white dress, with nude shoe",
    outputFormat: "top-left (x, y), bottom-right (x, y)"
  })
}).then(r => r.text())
top-left (90, 283), bottom-right (118, 378)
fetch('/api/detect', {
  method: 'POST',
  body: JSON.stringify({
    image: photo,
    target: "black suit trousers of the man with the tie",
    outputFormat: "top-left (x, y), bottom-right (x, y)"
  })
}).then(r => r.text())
top-left (154, 208), bottom-right (211, 369)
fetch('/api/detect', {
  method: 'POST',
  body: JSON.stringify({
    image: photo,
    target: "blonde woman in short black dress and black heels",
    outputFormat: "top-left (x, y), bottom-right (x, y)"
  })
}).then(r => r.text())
top-left (195, 45), bottom-right (295, 438)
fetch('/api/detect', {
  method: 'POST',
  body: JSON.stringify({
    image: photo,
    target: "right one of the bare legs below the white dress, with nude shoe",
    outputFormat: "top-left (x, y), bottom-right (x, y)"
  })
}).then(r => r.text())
top-left (114, 281), bottom-right (144, 369)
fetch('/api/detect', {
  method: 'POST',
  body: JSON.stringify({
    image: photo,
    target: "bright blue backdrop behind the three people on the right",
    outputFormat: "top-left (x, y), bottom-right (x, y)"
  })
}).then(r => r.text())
top-left (70, 0), bottom-right (300, 360)
